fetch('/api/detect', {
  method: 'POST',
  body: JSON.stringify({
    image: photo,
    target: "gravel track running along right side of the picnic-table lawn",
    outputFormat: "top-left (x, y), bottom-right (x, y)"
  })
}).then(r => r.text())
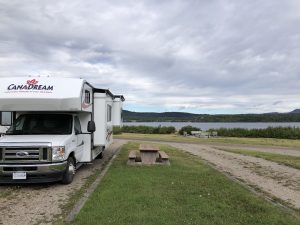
top-left (168, 143), bottom-right (300, 209)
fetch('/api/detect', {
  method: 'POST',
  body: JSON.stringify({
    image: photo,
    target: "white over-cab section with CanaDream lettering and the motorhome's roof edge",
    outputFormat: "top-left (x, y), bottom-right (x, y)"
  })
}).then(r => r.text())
top-left (0, 77), bottom-right (124, 111)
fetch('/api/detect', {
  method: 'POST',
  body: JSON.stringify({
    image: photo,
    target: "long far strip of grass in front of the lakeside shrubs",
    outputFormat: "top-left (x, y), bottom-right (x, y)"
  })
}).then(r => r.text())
top-left (114, 133), bottom-right (300, 148)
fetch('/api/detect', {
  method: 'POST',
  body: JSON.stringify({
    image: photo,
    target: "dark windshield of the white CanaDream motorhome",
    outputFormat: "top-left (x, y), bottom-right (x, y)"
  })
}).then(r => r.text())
top-left (6, 114), bottom-right (72, 134)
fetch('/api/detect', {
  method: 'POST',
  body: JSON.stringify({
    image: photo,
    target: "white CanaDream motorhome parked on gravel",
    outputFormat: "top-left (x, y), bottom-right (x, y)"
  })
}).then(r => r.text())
top-left (0, 77), bottom-right (125, 184)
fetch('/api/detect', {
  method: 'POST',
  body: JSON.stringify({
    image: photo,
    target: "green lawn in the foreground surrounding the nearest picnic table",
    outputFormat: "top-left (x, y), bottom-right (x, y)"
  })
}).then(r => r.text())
top-left (72, 142), bottom-right (300, 225)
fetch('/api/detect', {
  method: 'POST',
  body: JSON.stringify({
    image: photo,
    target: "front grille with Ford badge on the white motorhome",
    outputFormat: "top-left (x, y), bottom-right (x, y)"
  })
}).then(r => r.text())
top-left (0, 146), bottom-right (51, 163)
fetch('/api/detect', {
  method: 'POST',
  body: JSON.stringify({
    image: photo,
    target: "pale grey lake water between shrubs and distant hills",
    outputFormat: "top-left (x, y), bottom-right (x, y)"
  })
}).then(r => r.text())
top-left (123, 122), bottom-right (300, 131)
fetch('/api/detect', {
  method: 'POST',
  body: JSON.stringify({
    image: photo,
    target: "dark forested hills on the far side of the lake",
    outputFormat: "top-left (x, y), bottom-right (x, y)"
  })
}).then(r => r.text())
top-left (123, 109), bottom-right (300, 122)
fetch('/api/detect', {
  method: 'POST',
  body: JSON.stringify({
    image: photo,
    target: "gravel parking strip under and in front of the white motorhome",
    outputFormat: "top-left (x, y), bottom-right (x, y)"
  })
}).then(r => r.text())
top-left (0, 140), bottom-right (126, 225)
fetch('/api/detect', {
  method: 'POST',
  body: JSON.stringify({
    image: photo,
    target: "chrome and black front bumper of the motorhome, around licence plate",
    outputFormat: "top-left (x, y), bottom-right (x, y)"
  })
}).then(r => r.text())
top-left (0, 161), bottom-right (67, 184)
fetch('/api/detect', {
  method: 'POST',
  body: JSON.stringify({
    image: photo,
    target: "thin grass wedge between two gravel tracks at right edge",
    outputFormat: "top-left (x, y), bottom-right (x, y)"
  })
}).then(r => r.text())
top-left (219, 148), bottom-right (300, 169)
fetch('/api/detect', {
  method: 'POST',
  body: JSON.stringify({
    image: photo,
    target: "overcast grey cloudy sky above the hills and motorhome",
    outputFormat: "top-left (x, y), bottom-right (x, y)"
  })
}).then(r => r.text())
top-left (0, 0), bottom-right (300, 114)
